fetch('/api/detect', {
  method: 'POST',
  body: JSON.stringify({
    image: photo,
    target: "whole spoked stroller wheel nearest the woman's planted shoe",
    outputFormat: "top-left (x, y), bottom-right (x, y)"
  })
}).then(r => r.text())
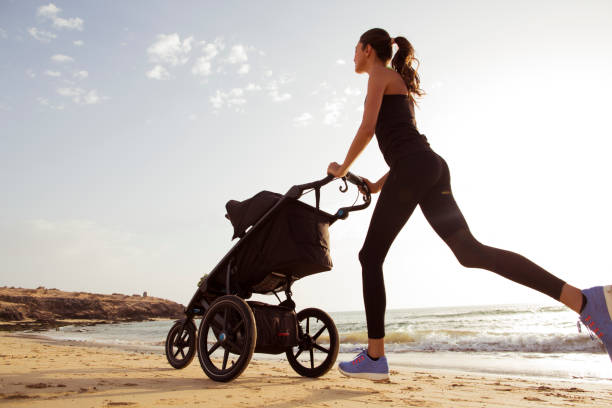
top-left (286, 308), bottom-right (340, 377)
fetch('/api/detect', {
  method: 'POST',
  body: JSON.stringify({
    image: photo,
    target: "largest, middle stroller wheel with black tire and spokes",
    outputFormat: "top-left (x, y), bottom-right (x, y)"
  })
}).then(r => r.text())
top-left (197, 295), bottom-right (257, 382)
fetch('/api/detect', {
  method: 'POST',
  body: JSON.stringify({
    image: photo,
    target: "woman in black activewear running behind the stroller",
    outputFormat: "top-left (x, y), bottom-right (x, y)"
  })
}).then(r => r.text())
top-left (327, 28), bottom-right (612, 380)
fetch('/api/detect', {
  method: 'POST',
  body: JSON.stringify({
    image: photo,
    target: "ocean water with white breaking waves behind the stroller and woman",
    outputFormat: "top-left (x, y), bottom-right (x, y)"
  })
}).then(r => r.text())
top-left (32, 305), bottom-right (612, 381)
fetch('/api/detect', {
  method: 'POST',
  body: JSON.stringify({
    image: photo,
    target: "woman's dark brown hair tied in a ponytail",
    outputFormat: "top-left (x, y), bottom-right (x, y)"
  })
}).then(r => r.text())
top-left (359, 28), bottom-right (425, 102)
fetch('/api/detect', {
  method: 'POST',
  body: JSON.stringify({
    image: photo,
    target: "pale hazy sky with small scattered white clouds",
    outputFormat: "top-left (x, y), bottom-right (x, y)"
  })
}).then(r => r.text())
top-left (0, 0), bottom-right (612, 312)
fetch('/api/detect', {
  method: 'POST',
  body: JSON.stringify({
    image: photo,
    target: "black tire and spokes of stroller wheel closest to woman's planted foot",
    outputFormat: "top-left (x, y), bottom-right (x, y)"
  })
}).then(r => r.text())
top-left (285, 308), bottom-right (340, 378)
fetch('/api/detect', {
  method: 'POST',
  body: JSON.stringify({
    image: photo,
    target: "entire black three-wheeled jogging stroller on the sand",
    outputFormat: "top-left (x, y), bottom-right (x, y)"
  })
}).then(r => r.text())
top-left (165, 173), bottom-right (371, 381)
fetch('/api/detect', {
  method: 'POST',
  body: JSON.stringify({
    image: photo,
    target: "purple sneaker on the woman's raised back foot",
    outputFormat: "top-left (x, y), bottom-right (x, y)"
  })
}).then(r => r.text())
top-left (580, 285), bottom-right (612, 360)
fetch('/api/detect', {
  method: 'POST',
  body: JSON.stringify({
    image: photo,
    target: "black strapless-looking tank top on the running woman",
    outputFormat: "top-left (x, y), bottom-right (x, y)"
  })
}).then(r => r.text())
top-left (375, 94), bottom-right (432, 167)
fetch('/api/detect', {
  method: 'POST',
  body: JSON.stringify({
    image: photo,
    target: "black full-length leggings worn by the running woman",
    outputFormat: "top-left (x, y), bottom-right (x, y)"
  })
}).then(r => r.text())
top-left (359, 152), bottom-right (565, 339)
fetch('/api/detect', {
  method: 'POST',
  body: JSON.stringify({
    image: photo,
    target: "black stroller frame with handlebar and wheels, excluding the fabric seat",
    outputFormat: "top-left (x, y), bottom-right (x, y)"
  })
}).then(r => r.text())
top-left (165, 172), bottom-right (371, 381)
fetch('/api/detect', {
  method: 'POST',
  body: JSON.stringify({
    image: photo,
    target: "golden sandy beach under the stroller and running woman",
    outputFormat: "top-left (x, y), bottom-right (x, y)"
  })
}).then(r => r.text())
top-left (0, 334), bottom-right (612, 408)
